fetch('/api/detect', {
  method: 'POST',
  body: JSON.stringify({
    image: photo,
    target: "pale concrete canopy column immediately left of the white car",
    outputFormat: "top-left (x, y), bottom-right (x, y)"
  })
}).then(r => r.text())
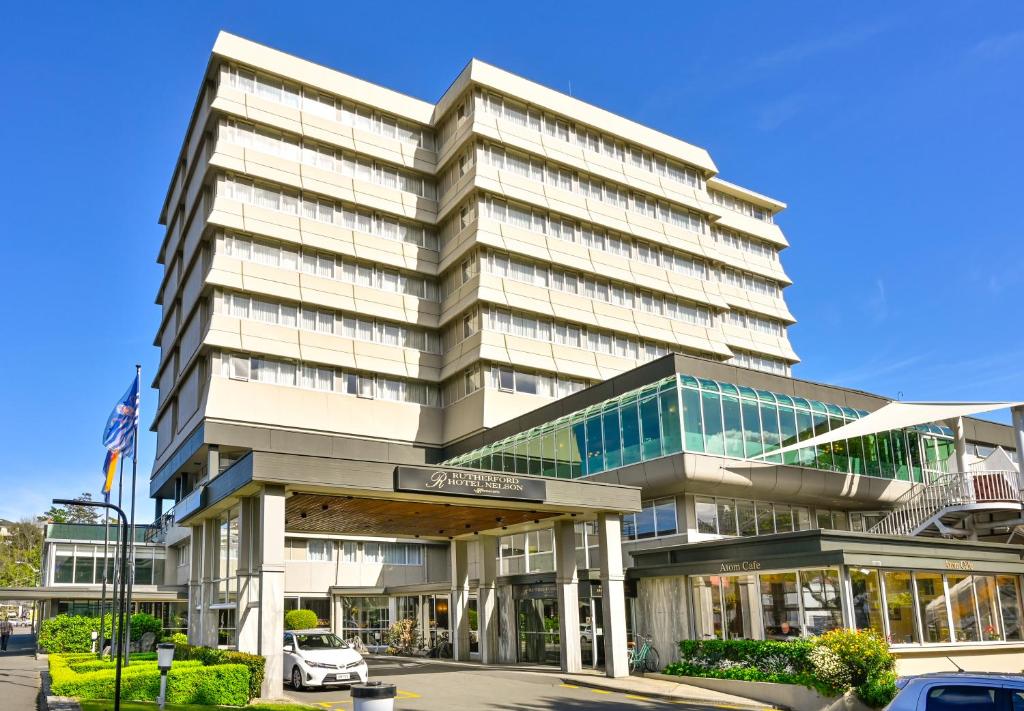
top-left (254, 486), bottom-right (285, 698)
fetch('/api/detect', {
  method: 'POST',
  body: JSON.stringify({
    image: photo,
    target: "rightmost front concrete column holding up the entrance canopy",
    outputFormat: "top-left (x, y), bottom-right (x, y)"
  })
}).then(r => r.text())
top-left (597, 513), bottom-right (630, 678)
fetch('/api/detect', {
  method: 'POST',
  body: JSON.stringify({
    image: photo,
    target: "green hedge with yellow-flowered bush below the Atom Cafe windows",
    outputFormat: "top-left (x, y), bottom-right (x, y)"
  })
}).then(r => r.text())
top-left (665, 629), bottom-right (896, 708)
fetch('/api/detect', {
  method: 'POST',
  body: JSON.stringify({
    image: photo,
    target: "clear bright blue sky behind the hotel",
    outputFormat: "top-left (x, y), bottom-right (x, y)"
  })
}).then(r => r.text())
top-left (0, 0), bottom-right (1024, 518)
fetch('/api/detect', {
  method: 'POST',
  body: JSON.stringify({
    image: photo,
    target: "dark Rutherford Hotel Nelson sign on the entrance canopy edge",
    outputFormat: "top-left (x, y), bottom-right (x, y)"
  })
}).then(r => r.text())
top-left (394, 466), bottom-right (547, 501)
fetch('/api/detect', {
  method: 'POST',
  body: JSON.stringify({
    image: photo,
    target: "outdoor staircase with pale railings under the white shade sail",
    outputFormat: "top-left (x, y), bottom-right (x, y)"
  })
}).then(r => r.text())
top-left (868, 469), bottom-right (1024, 537)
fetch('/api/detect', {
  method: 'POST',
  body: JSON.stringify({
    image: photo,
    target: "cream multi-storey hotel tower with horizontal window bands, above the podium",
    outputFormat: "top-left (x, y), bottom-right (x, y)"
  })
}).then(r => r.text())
top-left (155, 34), bottom-right (797, 479)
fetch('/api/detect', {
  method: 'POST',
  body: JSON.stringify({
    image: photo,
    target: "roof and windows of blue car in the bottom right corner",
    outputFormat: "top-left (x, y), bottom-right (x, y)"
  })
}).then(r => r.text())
top-left (885, 672), bottom-right (1024, 711)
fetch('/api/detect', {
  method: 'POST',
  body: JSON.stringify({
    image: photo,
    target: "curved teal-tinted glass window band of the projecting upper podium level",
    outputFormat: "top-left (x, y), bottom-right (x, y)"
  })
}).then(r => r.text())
top-left (444, 375), bottom-right (954, 482)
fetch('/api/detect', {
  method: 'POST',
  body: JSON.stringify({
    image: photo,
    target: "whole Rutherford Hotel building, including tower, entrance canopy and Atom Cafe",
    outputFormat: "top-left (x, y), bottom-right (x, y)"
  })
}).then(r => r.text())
top-left (32, 33), bottom-right (1024, 696)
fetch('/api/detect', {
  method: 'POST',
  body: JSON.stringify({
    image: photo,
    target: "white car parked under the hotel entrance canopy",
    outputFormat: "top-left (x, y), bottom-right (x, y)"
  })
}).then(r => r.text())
top-left (285, 629), bottom-right (368, 692)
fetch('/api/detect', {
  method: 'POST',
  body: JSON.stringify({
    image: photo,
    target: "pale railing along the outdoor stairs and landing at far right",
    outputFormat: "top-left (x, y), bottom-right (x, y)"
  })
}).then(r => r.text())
top-left (868, 469), bottom-right (1024, 536)
